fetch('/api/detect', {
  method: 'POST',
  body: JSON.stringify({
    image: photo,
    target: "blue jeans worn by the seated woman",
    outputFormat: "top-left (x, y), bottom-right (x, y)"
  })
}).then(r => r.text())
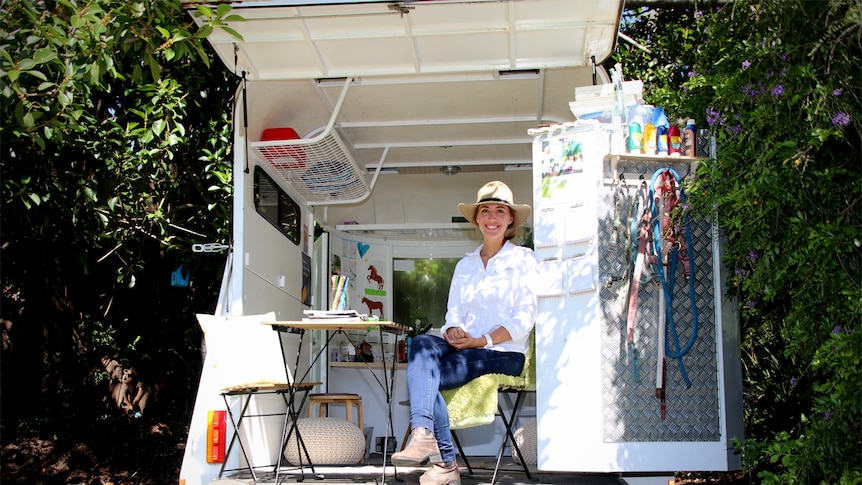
top-left (407, 334), bottom-right (526, 463)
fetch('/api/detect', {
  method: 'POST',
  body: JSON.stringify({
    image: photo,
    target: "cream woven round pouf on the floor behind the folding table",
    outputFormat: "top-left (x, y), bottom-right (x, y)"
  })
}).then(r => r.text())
top-left (284, 418), bottom-right (365, 466)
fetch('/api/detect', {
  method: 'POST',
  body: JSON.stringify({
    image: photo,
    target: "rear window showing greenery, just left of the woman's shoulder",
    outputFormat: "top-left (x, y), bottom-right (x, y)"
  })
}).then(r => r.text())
top-left (392, 258), bottom-right (460, 328)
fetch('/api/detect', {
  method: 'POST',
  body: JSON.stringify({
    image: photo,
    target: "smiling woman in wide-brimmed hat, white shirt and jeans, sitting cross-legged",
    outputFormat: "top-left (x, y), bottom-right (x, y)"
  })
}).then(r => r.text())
top-left (392, 181), bottom-right (538, 485)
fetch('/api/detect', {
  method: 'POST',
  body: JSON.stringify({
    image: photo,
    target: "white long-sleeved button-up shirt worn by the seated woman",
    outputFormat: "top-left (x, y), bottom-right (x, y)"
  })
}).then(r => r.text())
top-left (440, 241), bottom-right (539, 354)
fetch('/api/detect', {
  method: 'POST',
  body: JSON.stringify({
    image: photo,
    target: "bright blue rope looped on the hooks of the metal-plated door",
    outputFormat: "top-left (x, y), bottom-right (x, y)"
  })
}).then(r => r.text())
top-left (650, 168), bottom-right (698, 387)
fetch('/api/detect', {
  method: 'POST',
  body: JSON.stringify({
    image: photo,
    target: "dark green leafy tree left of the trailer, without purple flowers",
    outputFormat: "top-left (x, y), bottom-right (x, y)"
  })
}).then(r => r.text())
top-left (0, 0), bottom-right (237, 483)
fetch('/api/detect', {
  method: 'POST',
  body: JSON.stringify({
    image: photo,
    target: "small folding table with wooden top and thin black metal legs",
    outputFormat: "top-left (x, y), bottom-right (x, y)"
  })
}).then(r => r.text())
top-left (261, 318), bottom-right (410, 483)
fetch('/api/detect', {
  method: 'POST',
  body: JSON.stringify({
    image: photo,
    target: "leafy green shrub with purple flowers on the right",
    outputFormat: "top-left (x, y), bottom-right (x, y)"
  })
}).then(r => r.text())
top-left (613, 0), bottom-right (862, 483)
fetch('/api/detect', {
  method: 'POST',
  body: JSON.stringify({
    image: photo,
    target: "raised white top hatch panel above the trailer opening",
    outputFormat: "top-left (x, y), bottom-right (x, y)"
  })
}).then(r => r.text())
top-left (197, 0), bottom-right (622, 79)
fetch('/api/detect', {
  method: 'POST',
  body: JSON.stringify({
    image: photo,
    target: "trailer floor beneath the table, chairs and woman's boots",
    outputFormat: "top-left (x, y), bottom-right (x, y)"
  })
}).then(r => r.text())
top-left (210, 455), bottom-right (673, 485)
